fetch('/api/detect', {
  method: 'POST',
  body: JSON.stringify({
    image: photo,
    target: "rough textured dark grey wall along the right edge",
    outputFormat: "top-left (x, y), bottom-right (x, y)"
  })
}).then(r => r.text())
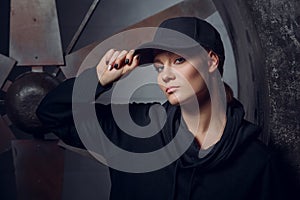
top-left (247, 0), bottom-right (300, 185)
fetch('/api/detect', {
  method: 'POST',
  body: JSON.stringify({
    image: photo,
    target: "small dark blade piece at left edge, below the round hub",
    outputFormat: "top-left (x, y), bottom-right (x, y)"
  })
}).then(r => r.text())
top-left (0, 116), bottom-right (15, 154)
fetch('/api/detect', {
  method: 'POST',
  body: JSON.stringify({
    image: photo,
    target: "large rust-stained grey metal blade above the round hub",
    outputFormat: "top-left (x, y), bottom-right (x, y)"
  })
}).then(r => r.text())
top-left (9, 0), bottom-right (64, 65)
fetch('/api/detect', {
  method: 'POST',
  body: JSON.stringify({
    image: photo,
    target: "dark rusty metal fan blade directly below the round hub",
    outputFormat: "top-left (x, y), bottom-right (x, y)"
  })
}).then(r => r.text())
top-left (12, 140), bottom-right (64, 200)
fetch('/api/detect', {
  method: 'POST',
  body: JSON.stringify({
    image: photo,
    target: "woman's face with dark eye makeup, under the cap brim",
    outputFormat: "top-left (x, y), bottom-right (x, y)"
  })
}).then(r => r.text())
top-left (154, 51), bottom-right (209, 105)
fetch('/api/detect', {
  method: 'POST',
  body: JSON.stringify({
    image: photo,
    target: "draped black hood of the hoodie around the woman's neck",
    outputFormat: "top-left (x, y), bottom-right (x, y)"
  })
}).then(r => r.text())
top-left (179, 99), bottom-right (260, 170)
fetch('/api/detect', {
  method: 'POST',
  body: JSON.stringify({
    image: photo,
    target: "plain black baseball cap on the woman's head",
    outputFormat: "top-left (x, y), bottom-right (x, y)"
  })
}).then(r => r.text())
top-left (136, 17), bottom-right (225, 65)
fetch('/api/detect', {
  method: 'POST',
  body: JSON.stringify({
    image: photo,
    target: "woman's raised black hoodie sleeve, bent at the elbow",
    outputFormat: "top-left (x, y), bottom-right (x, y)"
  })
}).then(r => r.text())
top-left (36, 68), bottom-right (163, 152)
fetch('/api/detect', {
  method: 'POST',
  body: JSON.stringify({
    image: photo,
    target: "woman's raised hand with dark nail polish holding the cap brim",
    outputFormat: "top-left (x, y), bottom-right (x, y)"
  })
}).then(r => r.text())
top-left (97, 49), bottom-right (139, 86)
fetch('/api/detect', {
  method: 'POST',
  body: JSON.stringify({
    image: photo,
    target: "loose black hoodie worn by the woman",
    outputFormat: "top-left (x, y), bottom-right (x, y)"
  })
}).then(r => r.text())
top-left (37, 69), bottom-right (284, 200)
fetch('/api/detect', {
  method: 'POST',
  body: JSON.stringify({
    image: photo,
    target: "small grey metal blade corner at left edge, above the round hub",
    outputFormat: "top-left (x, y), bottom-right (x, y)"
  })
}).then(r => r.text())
top-left (0, 54), bottom-right (16, 88)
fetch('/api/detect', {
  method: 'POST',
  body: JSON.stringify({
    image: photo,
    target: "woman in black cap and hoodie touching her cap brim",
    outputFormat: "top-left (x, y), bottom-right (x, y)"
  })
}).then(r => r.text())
top-left (37, 17), bottom-right (283, 200)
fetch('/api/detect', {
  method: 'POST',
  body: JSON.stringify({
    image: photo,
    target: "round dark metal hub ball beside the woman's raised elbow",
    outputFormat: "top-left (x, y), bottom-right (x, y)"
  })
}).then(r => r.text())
top-left (5, 72), bottom-right (59, 135)
